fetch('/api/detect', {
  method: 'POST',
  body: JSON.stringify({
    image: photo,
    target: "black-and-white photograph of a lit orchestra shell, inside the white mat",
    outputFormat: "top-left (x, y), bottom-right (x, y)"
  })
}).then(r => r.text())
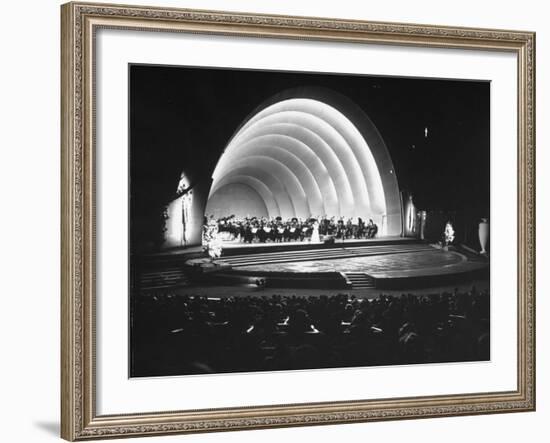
top-left (129, 65), bottom-right (491, 377)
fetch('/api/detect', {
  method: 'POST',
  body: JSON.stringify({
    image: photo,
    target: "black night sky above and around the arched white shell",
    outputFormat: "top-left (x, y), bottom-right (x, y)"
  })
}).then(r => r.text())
top-left (130, 65), bottom-right (490, 224)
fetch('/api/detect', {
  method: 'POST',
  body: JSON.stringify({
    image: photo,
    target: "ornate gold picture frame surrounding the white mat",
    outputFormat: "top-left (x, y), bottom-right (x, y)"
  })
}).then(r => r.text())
top-left (61, 2), bottom-right (535, 441)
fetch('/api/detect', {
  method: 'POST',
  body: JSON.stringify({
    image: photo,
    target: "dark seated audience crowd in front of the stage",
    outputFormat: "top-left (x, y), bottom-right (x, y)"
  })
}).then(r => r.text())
top-left (130, 287), bottom-right (490, 377)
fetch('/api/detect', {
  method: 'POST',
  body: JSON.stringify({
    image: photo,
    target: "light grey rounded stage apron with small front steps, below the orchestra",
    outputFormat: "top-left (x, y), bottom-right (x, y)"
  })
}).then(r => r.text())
top-left (210, 239), bottom-right (489, 288)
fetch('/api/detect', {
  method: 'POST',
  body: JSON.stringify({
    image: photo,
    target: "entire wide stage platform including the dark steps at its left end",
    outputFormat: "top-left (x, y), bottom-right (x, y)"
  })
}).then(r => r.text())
top-left (140, 237), bottom-right (489, 290)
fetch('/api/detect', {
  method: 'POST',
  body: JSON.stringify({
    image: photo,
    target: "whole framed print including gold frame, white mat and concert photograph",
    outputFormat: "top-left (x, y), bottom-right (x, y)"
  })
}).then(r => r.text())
top-left (61, 2), bottom-right (535, 440)
